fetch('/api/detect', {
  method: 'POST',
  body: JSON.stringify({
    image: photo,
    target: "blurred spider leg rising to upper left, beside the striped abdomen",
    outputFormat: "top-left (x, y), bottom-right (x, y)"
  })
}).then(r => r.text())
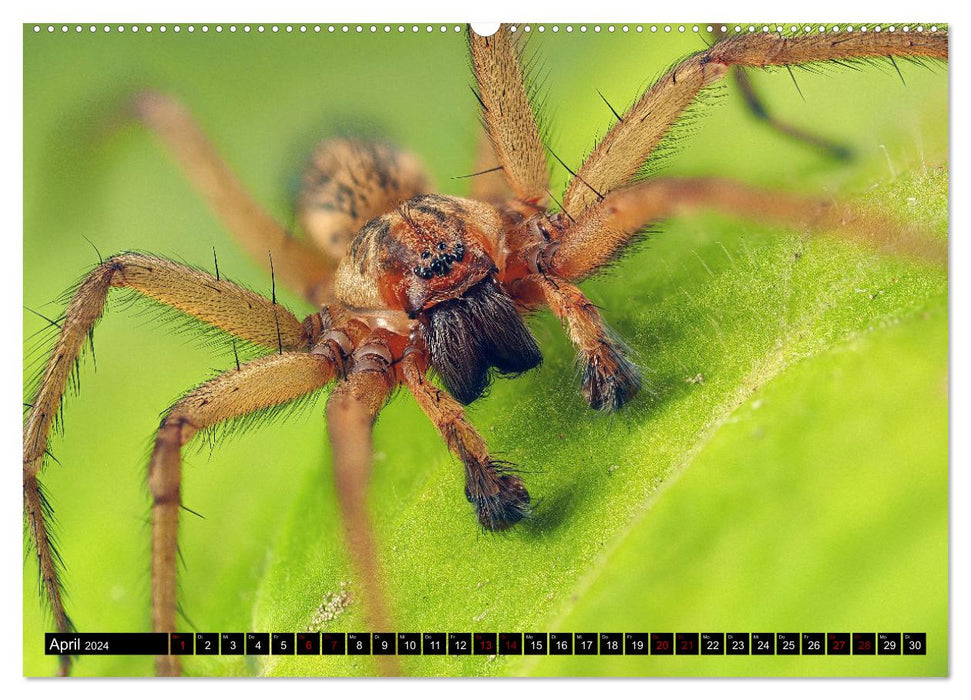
top-left (133, 91), bottom-right (334, 306)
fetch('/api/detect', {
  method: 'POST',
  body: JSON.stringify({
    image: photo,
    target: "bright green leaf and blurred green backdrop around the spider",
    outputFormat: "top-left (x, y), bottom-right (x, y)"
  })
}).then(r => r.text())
top-left (24, 25), bottom-right (948, 676)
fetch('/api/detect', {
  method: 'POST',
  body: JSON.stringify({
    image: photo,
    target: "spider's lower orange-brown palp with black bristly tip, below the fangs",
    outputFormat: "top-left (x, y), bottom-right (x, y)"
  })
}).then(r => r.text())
top-left (401, 347), bottom-right (529, 530)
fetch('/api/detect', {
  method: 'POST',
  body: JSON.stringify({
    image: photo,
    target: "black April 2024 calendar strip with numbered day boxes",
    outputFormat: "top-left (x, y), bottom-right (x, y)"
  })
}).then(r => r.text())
top-left (44, 632), bottom-right (927, 663)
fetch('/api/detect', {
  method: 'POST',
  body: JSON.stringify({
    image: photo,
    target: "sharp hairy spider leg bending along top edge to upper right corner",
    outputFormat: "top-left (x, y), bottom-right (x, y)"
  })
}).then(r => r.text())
top-left (563, 31), bottom-right (947, 218)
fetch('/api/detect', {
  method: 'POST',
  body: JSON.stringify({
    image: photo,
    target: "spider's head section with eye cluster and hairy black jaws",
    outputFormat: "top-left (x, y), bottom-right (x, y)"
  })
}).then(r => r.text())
top-left (336, 194), bottom-right (542, 404)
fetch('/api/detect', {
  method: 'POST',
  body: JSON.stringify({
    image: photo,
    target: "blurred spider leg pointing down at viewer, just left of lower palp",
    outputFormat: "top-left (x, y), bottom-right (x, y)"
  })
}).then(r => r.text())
top-left (327, 331), bottom-right (401, 676)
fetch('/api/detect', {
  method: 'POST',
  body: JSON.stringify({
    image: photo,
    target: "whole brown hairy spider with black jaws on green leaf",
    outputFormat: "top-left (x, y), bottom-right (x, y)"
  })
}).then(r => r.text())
top-left (24, 27), bottom-right (947, 674)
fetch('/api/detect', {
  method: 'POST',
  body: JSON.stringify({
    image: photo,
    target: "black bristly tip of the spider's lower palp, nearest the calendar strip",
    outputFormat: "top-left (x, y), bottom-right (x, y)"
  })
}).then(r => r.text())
top-left (465, 461), bottom-right (530, 532)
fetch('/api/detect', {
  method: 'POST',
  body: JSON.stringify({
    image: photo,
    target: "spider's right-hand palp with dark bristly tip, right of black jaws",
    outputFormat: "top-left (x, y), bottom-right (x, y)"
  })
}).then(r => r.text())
top-left (516, 273), bottom-right (641, 411)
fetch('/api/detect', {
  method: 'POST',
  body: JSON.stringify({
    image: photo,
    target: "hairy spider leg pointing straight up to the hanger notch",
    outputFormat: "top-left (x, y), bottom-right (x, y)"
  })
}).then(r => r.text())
top-left (468, 25), bottom-right (550, 209)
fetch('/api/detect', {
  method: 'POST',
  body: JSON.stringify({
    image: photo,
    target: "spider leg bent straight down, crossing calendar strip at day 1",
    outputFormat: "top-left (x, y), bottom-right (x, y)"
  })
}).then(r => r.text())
top-left (148, 352), bottom-right (335, 676)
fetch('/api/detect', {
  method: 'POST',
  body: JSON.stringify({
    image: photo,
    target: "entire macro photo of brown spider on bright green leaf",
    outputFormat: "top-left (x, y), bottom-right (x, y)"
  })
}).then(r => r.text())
top-left (23, 22), bottom-right (949, 677)
